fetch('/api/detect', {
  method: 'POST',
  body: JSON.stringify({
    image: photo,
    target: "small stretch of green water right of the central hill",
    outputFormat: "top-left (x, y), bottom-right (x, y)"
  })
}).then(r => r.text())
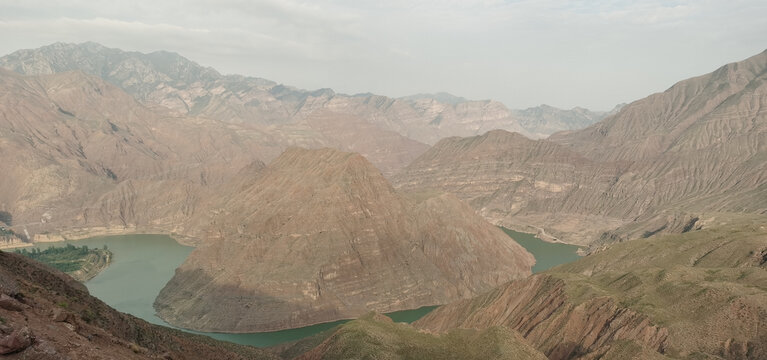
top-left (501, 227), bottom-right (580, 274)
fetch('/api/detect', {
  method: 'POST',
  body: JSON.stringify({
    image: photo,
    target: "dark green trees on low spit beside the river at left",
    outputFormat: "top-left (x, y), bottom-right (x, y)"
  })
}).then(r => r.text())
top-left (16, 244), bottom-right (112, 274)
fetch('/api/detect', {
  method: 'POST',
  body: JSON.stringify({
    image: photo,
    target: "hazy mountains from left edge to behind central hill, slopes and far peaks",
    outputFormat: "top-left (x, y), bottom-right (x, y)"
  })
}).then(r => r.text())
top-left (0, 43), bottom-right (616, 245)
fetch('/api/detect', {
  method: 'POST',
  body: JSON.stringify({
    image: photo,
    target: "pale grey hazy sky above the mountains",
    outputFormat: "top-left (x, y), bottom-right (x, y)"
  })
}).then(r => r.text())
top-left (0, 0), bottom-right (767, 110)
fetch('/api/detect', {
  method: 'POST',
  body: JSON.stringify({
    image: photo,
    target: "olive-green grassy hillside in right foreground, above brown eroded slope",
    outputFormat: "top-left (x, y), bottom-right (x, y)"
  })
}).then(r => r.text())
top-left (550, 221), bottom-right (767, 358)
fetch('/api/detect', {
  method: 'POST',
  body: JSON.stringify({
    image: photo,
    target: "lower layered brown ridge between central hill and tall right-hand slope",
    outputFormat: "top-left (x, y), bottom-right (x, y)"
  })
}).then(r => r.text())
top-left (394, 130), bottom-right (624, 243)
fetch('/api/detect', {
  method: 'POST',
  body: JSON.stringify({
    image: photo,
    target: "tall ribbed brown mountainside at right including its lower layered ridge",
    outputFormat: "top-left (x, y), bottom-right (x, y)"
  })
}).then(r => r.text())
top-left (394, 52), bottom-right (767, 244)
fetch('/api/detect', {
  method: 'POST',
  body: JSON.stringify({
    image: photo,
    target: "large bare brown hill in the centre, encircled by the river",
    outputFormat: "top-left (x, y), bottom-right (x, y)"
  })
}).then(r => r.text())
top-left (155, 148), bottom-right (534, 332)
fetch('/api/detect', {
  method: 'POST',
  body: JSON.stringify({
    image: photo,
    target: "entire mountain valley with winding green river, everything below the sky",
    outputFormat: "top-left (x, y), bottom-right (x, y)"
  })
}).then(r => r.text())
top-left (0, 38), bottom-right (767, 360)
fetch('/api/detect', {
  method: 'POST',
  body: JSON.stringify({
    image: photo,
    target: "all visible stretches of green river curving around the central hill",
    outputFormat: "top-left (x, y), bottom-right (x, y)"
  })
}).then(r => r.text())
top-left (33, 229), bottom-right (578, 347)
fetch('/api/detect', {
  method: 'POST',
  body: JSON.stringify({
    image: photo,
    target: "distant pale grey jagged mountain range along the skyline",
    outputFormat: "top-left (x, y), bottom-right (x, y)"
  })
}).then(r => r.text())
top-left (0, 43), bottom-right (600, 164)
